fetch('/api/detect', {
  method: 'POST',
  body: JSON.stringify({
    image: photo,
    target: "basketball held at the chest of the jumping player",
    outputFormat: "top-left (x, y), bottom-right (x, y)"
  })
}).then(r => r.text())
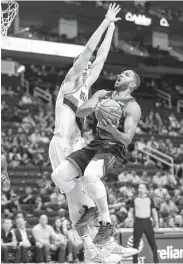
top-left (95, 99), bottom-right (122, 125)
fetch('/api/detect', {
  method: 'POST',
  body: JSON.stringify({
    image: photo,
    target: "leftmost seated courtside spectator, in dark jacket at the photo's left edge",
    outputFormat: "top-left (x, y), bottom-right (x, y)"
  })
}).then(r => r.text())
top-left (1, 218), bottom-right (18, 263)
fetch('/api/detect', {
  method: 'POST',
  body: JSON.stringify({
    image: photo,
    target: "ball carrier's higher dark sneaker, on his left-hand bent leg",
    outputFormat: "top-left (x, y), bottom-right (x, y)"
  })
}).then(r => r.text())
top-left (76, 206), bottom-right (98, 226)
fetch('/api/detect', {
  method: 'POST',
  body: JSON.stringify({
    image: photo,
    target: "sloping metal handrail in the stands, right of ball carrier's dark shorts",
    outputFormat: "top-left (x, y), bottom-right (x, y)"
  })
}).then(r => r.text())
top-left (138, 144), bottom-right (174, 175)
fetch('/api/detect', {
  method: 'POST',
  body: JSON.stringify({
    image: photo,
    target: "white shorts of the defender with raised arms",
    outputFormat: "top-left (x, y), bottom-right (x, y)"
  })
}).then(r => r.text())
top-left (49, 135), bottom-right (84, 170)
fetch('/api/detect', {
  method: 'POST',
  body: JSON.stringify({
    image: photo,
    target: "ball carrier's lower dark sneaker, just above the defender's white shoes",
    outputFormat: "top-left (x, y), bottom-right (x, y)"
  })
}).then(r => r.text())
top-left (93, 222), bottom-right (115, 244)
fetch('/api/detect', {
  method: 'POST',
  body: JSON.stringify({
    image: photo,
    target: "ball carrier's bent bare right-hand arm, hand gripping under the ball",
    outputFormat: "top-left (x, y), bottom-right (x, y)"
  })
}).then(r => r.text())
top-left (100, 102), bottom-right (141, 146)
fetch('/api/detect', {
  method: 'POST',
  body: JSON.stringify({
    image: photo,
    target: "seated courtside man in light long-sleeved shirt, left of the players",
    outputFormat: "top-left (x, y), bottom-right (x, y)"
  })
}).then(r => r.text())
top-left (32, 215), bottom-right (60, 263)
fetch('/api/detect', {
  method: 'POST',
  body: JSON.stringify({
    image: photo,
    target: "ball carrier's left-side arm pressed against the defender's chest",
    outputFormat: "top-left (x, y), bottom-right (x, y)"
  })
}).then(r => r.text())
top-left (76, 90), bottom-right (108, 118)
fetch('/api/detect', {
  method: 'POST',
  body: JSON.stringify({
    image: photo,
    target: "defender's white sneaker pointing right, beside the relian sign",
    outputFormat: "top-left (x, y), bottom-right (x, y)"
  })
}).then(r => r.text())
top-left (99, 237), bottom-right (138, 258)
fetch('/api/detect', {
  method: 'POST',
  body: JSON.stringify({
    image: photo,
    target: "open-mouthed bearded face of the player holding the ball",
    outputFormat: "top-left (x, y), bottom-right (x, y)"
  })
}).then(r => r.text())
top-left (114, 70), bottom-right (134, 90)
